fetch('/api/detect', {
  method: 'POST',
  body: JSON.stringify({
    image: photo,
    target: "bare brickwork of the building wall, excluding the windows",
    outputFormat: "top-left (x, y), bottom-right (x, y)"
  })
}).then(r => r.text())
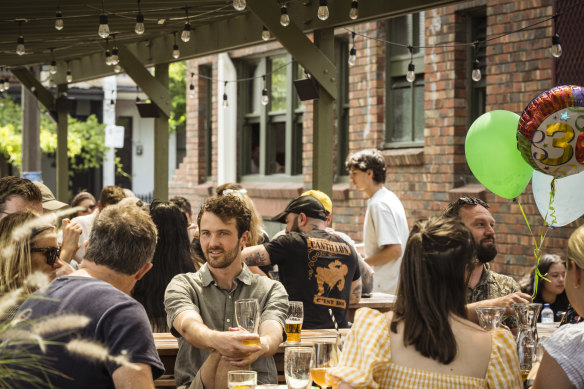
top-left (170, 0), bottom-right (582, 278)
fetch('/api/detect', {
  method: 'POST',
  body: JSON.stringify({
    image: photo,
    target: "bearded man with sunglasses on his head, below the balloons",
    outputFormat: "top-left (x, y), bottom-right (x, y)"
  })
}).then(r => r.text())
top-left (444, 197), bottom-right (531, 328)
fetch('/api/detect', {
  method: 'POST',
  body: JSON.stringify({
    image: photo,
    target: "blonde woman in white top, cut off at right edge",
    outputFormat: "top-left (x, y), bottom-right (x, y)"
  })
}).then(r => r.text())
top-left (533, 226), bottom-right (584, 389)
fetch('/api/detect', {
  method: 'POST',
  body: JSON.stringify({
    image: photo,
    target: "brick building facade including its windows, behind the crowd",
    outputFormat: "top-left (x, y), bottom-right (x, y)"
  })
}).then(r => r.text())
top-left (170, 0), bottom-right (584, 279)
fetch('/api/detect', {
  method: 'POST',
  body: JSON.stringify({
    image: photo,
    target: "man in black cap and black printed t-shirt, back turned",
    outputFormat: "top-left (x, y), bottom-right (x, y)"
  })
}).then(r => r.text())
top-left (242, 195), bottom-right (361, 329)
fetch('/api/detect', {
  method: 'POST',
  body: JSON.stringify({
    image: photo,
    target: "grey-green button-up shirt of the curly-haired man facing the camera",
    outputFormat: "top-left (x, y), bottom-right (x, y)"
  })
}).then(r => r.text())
top-left (164, 264), bottom-right (288, 386)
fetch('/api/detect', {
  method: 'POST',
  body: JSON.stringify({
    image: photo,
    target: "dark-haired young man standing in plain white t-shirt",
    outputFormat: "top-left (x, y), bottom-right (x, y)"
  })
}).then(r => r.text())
top-left (345, 149), bottom-right (409, 294)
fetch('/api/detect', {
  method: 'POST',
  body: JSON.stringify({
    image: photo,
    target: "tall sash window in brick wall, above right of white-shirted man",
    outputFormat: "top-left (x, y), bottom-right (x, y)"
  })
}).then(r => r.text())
top-left (384, 12), bottom-right (424, 148)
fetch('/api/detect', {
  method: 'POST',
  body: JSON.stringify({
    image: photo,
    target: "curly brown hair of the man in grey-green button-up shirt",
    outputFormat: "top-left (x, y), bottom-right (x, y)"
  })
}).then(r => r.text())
top-left (197, 194), bottom-right (251, 238)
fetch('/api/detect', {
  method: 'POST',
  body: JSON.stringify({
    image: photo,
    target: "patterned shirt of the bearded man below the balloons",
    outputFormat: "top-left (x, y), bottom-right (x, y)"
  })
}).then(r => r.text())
top-left (466, 264), bottom-right (521, 328)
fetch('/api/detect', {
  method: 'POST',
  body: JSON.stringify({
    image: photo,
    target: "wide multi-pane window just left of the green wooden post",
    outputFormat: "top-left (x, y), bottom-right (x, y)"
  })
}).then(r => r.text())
top-left (238, 55), bottom-right (304, 181)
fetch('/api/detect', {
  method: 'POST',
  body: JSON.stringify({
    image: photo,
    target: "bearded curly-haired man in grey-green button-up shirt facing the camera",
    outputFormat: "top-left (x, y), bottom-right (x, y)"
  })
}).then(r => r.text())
top-left (164, 195), bottom-right (288, 389)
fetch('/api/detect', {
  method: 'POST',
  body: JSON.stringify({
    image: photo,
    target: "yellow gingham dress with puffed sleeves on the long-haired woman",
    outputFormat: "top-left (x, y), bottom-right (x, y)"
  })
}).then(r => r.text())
top-left (329, 308), bottom-right (523, 389)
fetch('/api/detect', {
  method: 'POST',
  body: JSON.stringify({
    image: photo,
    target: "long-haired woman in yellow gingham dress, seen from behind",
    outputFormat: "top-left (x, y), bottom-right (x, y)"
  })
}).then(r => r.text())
top-left (329, 217), bottom-right (523, 389)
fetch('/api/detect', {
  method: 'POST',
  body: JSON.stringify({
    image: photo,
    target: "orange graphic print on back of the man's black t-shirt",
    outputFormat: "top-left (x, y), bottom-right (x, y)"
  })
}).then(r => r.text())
top-left (306, 238), bottom-right (351, 308)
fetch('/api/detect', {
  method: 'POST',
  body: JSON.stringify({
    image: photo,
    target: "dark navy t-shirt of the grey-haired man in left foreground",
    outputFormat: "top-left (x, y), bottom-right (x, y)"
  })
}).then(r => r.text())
top-left (10, 276), bottom-right (164, 389)
